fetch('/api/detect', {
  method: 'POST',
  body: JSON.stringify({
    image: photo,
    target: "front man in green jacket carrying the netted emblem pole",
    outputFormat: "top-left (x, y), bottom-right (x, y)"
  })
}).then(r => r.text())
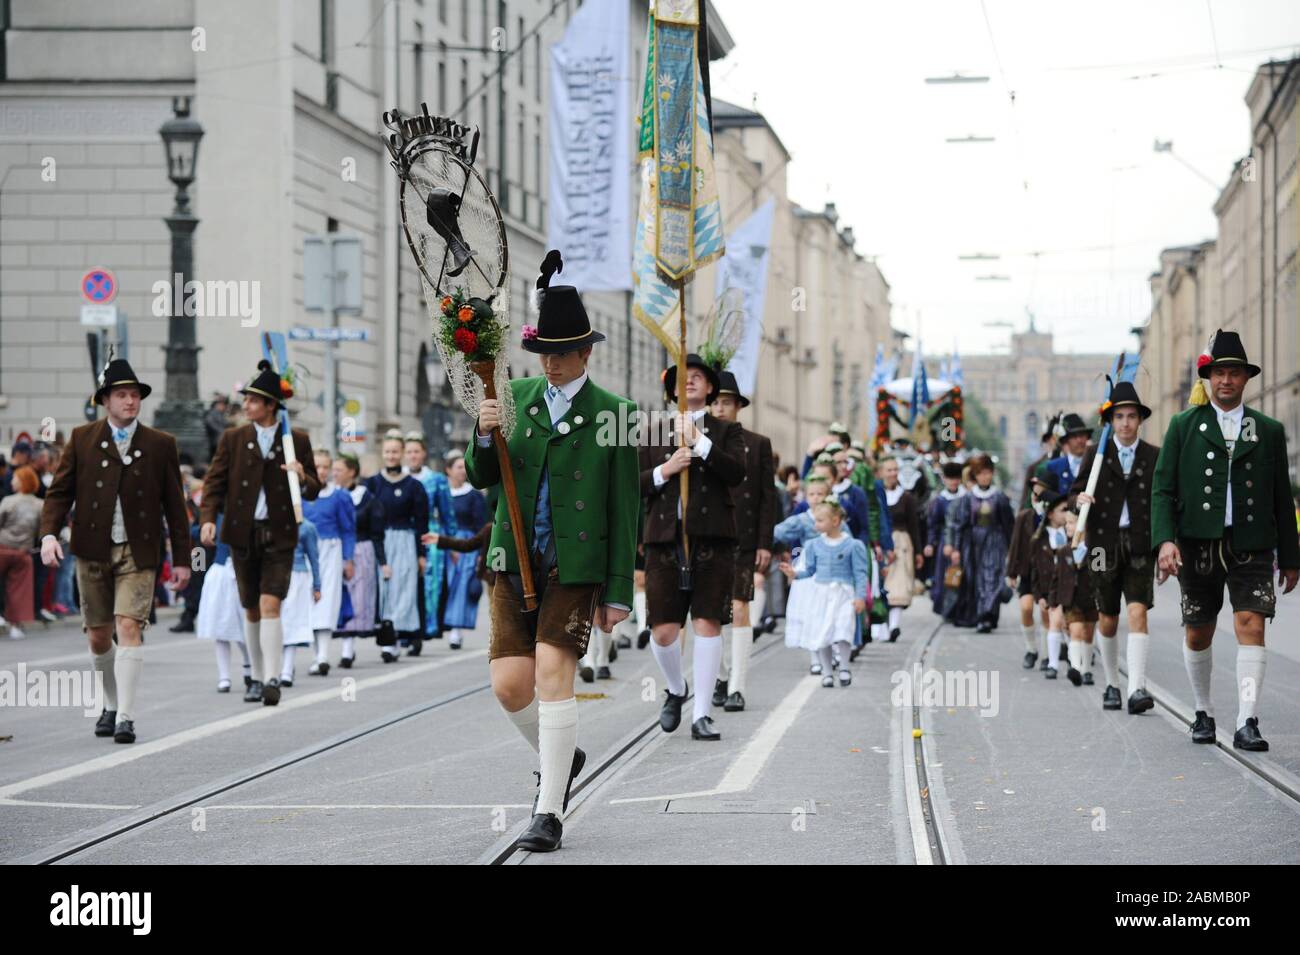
top-left (465, 252), bottom-right (641, 852)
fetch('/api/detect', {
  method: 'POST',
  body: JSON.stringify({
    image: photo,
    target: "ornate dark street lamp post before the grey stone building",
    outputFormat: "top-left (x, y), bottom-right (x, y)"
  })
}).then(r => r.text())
top-left (153, 96), bottom-right (208, 464)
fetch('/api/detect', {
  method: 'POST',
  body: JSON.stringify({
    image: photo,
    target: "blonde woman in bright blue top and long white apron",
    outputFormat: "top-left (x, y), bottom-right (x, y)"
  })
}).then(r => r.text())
top-left (303, 450), bottom-right (356, 676)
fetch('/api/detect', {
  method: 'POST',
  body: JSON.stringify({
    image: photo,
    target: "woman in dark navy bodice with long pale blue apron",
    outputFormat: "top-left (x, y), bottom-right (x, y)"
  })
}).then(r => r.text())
top-left (365, 430), bottom-right (429, 663)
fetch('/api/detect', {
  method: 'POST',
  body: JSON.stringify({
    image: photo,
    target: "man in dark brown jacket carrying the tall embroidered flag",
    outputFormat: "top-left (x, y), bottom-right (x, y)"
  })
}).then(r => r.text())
top-left (641, 355), bottom-right (745, 739)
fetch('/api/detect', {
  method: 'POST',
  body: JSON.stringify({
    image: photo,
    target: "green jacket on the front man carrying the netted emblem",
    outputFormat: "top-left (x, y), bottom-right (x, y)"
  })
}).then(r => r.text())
top-left (465, 376), bottom-right (641, 607)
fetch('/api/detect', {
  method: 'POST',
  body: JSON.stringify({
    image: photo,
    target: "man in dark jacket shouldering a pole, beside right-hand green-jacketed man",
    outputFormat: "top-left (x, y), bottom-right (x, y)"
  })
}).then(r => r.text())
top-left (1070, 382), bottom-right (1160, 715)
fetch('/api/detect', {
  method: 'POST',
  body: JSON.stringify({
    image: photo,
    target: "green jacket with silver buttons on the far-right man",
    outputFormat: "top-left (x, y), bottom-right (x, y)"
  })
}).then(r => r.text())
top-left (1151, 404), bottom-right (1300, 569)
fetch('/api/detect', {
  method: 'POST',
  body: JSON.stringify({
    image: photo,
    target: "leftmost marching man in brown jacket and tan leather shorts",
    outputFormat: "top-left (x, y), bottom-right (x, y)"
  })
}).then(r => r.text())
top-left (40, 359), bottom-right (190, 743)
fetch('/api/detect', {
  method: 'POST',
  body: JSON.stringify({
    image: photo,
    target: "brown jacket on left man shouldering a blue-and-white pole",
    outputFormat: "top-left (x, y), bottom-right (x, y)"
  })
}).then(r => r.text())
top-left (200, 422), bottom-right (321, 551)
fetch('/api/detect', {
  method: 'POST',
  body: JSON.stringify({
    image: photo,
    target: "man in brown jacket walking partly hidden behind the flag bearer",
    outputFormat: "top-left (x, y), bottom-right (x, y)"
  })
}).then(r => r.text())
top-left (712, 372), bottom-right (777, 713)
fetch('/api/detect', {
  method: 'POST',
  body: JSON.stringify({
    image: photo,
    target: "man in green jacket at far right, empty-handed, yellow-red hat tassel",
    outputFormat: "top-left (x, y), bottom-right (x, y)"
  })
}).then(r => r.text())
top-left (1151, 330), bottom-right (1300, 752)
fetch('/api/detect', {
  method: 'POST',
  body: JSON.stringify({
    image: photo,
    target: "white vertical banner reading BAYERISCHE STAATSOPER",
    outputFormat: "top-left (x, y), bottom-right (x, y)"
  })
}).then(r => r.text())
top-left (546, 0), bottom-right (632, 291)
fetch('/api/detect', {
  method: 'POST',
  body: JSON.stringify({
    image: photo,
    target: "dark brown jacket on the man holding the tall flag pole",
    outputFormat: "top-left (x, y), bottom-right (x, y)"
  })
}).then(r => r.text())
top-left (640, 412), bottom-right (745, 544)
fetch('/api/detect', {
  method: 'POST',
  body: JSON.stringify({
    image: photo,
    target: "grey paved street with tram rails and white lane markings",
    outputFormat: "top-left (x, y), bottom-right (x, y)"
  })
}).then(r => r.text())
top-left (0, 585), bottom-right (1300, 864)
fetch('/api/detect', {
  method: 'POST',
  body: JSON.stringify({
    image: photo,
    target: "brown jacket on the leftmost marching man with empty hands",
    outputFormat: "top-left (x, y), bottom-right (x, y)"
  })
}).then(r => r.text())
top-left (40, 418), bottom-right (190, 568)
